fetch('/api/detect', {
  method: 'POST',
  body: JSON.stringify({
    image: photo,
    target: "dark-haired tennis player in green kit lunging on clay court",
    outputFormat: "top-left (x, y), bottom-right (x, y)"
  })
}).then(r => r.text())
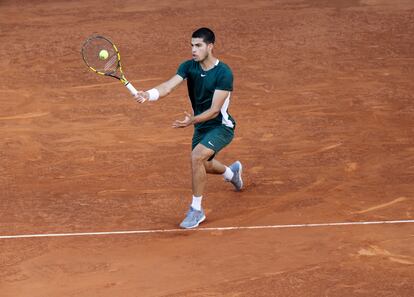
top-left (136, 28), bottom-right (243, 229)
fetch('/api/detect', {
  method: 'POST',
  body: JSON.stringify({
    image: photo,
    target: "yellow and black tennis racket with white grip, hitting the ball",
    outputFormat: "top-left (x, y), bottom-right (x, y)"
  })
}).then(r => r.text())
top-left (81, 35), bottom-right (138, 96)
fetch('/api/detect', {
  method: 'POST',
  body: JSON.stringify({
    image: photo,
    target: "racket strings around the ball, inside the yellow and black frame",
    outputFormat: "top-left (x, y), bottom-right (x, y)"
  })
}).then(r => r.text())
top-left (82, 36), bottom-right (119, 74)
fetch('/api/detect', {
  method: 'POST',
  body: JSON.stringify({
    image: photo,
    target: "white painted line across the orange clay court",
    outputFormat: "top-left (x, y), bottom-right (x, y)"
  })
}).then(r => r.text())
top-left (0, 220), bottom-right (414, 239)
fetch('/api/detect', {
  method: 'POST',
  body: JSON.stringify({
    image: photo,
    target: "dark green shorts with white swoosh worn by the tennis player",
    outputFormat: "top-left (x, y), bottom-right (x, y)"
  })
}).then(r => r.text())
top-left (192, 125), bottom-right (234, 161)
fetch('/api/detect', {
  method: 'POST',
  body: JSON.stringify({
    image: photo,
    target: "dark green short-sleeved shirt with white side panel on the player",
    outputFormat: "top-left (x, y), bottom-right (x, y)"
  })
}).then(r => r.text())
top-left (177, 60), bottom-right (236, 129)
